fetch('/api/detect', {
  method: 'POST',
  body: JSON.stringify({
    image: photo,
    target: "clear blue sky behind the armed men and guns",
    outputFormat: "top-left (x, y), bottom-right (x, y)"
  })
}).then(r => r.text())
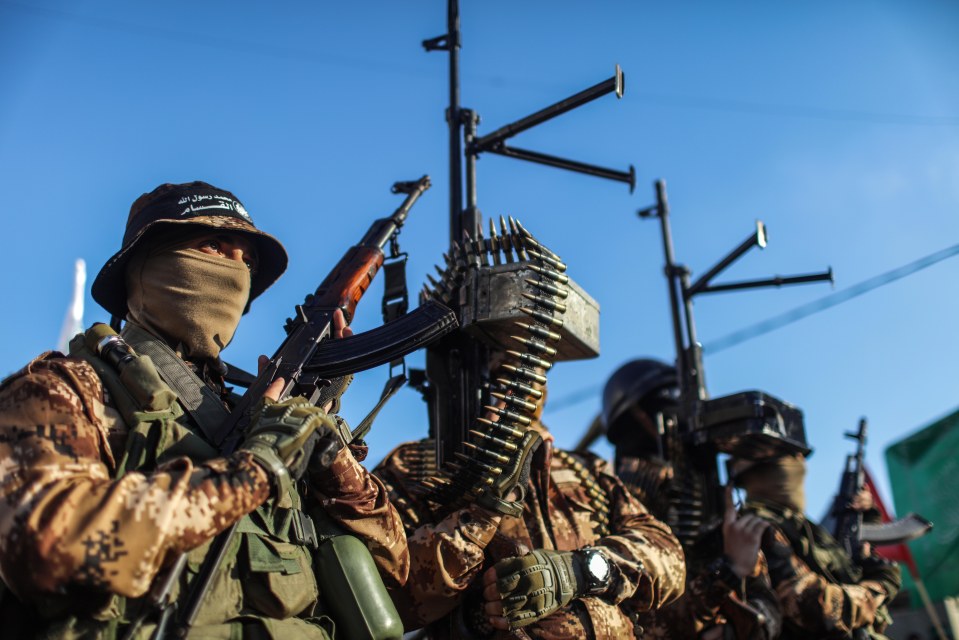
top-left (0, 0), bottom-right (959, 513)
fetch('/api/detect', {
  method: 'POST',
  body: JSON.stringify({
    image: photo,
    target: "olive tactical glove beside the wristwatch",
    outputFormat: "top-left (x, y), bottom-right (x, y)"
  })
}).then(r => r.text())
top-left (493, 549), bottom-right (587, 629)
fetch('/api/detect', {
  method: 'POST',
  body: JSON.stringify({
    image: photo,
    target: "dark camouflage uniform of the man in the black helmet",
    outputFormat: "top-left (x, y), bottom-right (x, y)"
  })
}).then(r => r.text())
top-left (618, 456), bottom-right (782, 640)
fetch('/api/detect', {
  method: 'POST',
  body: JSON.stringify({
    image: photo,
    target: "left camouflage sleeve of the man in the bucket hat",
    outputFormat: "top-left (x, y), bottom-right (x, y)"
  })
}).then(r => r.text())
top-left (0, 359), bottom-right (269, 599)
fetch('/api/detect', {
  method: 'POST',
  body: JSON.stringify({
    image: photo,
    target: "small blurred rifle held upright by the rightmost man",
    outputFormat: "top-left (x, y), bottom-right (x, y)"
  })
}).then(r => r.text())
top-left (823, 418), bottom-right (932, 559)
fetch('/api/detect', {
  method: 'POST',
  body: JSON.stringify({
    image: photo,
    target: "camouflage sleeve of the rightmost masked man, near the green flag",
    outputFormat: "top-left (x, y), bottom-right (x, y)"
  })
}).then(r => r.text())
top-left (763, 527), bottom-right (887, 638)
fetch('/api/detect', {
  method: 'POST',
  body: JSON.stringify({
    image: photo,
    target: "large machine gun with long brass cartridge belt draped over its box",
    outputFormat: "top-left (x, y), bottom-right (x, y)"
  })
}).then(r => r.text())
top-left (411, 0), bottom-right (636, 508)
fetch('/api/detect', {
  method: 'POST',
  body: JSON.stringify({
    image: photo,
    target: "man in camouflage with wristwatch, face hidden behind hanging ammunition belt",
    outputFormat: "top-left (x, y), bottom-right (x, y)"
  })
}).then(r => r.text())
top-left (374, 380), bottom-right (685, 640)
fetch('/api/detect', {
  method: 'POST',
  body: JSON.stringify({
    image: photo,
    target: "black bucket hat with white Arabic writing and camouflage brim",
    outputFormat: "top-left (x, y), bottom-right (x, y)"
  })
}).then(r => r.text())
top-left (91, 181), bottom-right (287, 318)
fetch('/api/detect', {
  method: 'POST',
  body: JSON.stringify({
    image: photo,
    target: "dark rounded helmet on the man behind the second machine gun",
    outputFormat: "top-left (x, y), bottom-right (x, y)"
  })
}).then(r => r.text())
top-left (603, 358), bottom-right (679, 452)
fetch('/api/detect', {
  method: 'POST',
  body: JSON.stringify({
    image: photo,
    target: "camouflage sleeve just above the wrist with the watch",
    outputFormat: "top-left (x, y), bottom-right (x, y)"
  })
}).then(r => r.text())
top-left (594, 459), bottom-right (686, 611)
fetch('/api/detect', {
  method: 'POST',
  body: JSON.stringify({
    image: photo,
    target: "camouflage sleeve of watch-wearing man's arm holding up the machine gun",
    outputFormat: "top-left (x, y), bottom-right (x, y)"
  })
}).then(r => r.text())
top-left (375, 445), bottom-right (501, 629)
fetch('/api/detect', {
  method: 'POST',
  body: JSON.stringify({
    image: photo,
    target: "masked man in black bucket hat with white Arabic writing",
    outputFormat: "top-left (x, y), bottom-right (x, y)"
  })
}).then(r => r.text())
top-left (0, 182), bottom-right (408, 638)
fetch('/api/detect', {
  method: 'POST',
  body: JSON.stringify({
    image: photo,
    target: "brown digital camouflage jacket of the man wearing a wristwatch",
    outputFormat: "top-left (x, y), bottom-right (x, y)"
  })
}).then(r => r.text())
top-left (374, 440), bottom-right (685, 640)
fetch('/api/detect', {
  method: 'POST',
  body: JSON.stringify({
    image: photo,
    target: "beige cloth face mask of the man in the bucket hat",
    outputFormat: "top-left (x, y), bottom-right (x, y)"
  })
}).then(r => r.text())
top-left (126, 247), bottom-right (250, 359)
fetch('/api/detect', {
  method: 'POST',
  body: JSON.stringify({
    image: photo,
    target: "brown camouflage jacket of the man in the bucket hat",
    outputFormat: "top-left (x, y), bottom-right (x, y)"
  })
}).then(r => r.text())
top-left (0, 353), bottom-right (409, 638)
